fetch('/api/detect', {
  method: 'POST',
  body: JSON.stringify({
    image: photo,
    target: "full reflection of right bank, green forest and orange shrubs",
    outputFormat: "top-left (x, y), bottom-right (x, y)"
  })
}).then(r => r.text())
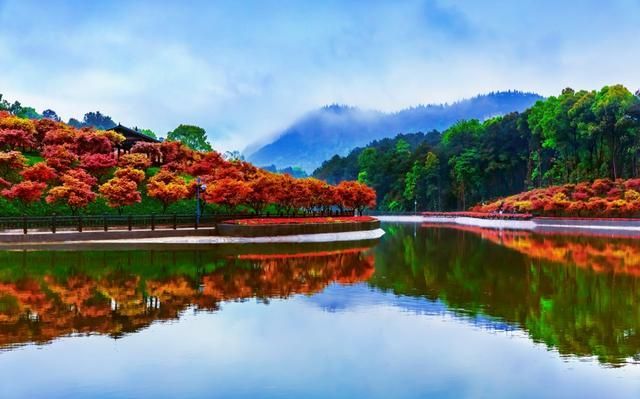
top-left (369, 226), bottom-right (640, 364)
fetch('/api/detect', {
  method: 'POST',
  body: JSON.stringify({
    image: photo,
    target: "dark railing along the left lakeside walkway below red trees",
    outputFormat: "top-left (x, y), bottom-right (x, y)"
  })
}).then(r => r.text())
top-left (0, 211), bottom-right (354, 234)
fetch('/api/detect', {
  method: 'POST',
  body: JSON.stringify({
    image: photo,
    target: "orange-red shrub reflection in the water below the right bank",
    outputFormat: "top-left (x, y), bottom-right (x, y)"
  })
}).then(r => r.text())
top-left (423, 224), bottom-right (640, 276)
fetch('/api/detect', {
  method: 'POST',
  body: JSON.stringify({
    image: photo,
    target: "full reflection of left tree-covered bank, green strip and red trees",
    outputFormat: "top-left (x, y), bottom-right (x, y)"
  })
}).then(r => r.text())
top-left (0, 249), bottom-right (373, 347)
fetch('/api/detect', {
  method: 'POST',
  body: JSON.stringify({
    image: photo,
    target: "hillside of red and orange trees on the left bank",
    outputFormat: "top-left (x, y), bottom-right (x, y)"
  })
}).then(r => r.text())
top-left (0, 110), bottom-right (376, 216)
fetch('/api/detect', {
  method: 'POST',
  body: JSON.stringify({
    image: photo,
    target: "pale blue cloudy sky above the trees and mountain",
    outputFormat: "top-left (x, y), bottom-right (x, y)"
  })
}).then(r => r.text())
top-left (0, 0), bottom-right (640, 150)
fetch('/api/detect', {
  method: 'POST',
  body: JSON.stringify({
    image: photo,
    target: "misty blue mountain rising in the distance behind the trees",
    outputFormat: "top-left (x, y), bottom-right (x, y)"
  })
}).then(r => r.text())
top-left (248, 91), bottom-right (542, 172)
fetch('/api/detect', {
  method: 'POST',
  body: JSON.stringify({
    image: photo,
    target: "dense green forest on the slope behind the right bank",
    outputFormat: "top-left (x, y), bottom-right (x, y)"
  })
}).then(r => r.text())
top-left (314, 85), bottom-right (640, 211)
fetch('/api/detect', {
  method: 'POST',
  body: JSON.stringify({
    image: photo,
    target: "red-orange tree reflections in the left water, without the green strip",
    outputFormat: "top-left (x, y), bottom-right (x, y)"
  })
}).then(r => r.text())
top-left (0, 248), bottom-right (374, 347)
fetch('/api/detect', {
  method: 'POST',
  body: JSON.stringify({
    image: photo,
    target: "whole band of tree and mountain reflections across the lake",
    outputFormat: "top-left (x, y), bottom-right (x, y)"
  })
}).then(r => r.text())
top-left (0, 224), bottom-right (640, 366)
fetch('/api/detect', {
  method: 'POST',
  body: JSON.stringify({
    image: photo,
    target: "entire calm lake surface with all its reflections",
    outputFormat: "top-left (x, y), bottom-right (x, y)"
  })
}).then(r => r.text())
top-left (0, 224), bottom-right (640, 398)
